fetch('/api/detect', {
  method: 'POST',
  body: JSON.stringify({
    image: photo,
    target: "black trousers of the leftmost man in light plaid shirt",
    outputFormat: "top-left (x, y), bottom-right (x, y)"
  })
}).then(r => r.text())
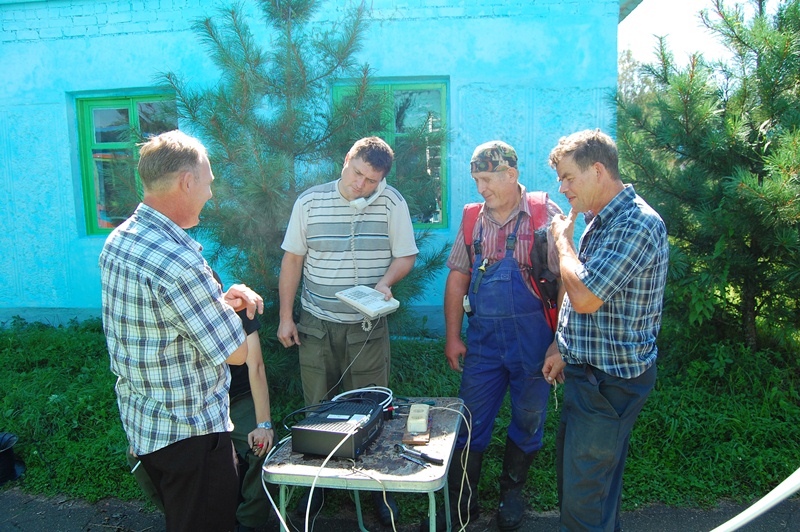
top-left (139, 432), bottom-right (239, 532)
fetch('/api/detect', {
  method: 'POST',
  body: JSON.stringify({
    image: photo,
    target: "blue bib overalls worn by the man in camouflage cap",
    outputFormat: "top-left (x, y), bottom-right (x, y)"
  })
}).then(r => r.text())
top-left (456, 213), bottom-right (553, 453)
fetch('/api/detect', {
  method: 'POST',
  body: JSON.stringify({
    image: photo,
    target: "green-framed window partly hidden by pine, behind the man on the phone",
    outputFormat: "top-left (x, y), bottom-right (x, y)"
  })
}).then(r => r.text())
top-left (333, 79), bottom-right (447, 228)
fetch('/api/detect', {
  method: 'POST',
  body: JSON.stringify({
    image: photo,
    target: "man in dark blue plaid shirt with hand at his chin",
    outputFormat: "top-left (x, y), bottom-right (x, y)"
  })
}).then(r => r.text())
top-left (542, 129), bottom-right (669, 532)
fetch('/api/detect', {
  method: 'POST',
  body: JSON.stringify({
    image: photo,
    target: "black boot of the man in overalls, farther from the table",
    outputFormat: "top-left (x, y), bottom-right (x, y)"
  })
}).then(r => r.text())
top-left (497, 438), bottom-right (539, 532)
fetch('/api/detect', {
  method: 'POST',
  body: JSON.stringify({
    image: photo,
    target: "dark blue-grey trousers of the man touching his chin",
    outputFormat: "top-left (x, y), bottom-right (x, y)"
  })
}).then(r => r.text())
top-left (556, 364), bottom-right (656, 532)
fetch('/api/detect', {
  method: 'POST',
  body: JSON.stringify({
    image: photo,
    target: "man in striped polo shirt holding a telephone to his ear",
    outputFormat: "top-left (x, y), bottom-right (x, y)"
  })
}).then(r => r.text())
top-left (278, 137), bottom-right (419, 525)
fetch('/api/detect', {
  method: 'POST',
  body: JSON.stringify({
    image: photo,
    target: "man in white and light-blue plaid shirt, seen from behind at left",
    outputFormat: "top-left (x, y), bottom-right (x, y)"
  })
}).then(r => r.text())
top-left (100, 131), bottom-right (264, 531)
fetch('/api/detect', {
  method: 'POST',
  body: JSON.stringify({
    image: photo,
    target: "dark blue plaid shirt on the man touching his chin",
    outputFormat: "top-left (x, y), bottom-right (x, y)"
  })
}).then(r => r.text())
top-left (556, 185), bottom-right (669, 379)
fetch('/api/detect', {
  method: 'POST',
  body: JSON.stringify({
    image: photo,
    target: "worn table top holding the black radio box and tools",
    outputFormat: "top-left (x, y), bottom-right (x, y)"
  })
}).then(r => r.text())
top-left (262, 397), bottom-right (463, 492)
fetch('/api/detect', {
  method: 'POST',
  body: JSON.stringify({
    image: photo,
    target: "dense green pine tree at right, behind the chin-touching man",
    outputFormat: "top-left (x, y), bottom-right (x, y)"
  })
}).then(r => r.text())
top-left (617, 0), bottom-right (800, 350)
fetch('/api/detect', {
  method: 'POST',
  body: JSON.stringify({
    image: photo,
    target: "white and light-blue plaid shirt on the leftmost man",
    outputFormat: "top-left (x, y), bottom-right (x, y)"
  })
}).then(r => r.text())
top-left (100, 204), bottom-right (245, 454)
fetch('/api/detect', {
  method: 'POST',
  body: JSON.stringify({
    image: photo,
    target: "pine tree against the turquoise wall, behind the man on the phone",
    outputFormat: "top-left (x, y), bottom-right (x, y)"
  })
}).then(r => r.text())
top-left (163, 0), bottom-right (446, 362)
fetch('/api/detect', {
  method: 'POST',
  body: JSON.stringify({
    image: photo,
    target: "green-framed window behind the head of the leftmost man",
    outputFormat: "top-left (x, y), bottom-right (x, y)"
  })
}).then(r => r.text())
top-left (76, 95), bottom-right (178, 235)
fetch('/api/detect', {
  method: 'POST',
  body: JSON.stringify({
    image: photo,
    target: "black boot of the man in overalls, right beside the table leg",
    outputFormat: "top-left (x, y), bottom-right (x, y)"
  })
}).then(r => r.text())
top-left (419, 449), bottom-right (483, 532)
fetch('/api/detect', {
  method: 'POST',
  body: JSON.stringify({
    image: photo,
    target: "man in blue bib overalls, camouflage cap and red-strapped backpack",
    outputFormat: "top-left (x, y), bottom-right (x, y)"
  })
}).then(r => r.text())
top-left (424, 141), bottom-right (561, 530)
